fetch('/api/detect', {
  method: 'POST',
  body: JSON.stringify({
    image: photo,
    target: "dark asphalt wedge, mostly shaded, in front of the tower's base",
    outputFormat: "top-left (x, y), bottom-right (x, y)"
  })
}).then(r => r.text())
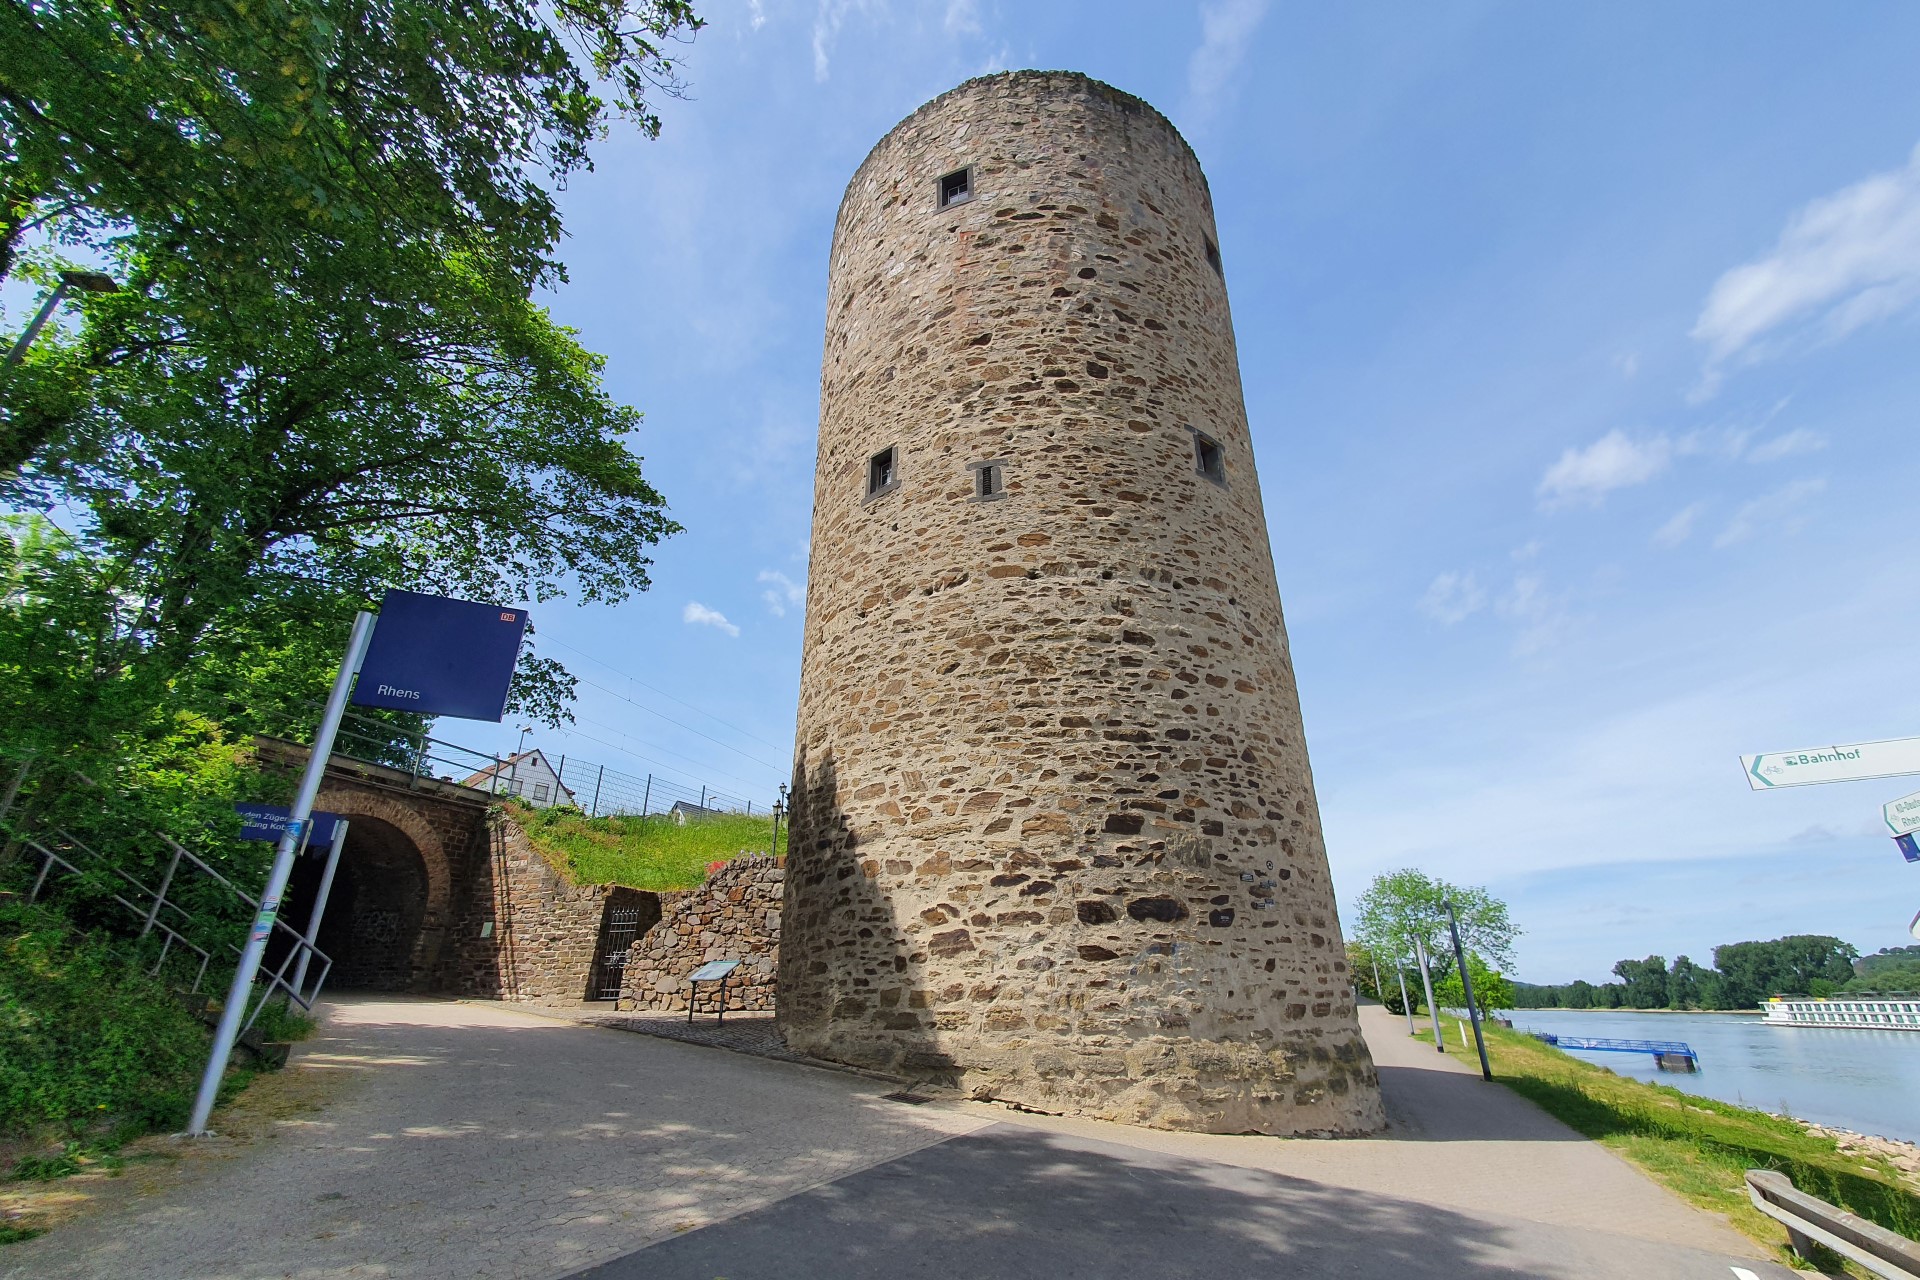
top-left (576, 1125), bottom-right (1766, 1280)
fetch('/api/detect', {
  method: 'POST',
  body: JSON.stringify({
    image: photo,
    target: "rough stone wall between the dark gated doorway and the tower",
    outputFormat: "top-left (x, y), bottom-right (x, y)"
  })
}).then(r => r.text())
top-left (626, 854), bottom-right (787, 1011)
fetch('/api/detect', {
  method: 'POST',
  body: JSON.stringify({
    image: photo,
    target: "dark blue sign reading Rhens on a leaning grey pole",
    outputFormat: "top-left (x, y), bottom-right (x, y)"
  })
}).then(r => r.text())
top-left (353, 591), bottom-right (526, 723)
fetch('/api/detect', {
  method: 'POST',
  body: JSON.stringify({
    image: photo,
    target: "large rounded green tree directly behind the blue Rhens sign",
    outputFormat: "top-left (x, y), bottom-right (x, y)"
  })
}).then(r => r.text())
top-left (15, 231), bottom-right (678, 731)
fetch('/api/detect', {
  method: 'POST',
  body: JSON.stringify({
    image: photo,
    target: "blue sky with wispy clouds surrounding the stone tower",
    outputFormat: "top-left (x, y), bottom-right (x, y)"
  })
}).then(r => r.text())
top-left (445, 0), bottom-right (1920, 981)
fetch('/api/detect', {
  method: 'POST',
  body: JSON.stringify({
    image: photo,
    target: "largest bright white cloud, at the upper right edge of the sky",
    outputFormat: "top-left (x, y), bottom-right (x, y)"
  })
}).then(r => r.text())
top-left (1693, 148), bottom-right (1920, 383)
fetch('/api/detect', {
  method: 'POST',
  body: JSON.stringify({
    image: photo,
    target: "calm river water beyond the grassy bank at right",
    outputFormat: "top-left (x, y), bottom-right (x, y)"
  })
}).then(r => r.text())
top-left (1497, 1009), bottom-right (1920, 1142)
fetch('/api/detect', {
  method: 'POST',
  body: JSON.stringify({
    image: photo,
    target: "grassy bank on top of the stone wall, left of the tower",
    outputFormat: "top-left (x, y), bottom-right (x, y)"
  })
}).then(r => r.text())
top-left (505, 802), bottom-right (787, 892)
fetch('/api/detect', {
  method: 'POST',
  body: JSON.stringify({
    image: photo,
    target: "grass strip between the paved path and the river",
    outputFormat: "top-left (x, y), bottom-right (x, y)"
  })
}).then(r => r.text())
top-left (1421, 1025), bottom-right (1920, 1261)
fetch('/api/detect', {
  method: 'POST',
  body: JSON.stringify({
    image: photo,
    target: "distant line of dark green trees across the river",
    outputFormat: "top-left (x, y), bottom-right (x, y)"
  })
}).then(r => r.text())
top-left (1513, 935), bottom-right (1920, 1009)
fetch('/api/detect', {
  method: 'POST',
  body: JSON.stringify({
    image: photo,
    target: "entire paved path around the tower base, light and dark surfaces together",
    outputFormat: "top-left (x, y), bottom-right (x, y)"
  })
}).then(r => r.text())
top-left (0, 1000), bottom-right (1791, 1280)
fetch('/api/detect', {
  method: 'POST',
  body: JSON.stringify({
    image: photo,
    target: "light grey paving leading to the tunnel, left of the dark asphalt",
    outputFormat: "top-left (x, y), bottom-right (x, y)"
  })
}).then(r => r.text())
top-left (0, 998), bottom-right (993, 1280)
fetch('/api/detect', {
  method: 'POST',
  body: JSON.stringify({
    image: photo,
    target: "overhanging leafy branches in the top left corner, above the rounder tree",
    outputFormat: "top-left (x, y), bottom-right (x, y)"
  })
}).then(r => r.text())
top-left (0, 0), bottom-right (701, 284)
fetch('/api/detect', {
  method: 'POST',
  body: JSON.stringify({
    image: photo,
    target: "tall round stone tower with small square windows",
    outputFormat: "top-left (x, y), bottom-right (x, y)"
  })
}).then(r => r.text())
top-left (780, 71), bottom-right (1382, 1134)
